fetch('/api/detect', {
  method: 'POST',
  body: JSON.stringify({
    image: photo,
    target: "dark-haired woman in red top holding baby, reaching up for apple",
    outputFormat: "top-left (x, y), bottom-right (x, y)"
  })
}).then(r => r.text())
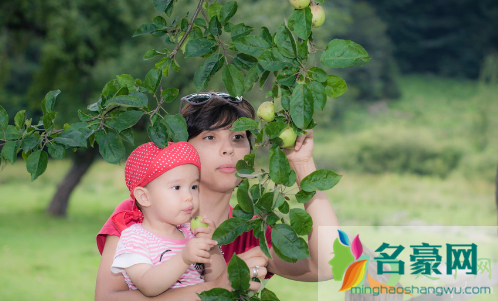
top-left (95, 93), bottom-right (339, 301)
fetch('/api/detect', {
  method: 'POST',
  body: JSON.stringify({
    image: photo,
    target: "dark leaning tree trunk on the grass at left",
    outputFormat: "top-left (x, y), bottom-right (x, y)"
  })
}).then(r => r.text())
top-left (47, 147), bottom-right (98, 216)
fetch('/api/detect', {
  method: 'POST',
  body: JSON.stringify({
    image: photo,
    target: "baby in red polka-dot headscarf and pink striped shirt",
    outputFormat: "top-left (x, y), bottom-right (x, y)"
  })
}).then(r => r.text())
top-left (111, 142), bottom-right (226, 297)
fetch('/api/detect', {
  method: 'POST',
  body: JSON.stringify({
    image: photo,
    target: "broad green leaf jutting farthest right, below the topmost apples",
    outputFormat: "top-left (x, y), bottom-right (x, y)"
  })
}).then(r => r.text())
top-left (320, 39), bottom-right (370, 68)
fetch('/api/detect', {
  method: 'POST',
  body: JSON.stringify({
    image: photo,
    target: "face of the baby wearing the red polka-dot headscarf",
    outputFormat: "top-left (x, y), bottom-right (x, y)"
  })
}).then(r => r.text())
top-left (147, 164), bottom-right (199, 225)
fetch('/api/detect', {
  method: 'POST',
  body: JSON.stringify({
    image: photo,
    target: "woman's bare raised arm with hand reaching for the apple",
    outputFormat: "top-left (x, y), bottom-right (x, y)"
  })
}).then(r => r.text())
top-left (268, 130), bottom-right (339, 281)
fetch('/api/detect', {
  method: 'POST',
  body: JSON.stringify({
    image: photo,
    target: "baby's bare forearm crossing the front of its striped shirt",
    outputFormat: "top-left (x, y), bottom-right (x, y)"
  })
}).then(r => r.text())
top-left (125, 238), bottom-right (216, 297)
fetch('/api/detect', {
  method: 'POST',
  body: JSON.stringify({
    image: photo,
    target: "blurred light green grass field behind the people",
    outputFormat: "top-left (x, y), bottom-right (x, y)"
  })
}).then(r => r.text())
top-left (0, 77), bottom-right (498, 301)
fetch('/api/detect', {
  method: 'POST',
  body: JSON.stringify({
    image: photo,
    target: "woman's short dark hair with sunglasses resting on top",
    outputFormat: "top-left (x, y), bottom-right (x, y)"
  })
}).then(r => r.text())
top-left (181, 95), bottom-right (255, 150)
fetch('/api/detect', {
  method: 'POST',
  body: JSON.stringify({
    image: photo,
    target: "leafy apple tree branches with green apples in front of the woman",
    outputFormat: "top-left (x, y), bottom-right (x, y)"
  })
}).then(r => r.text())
top-left (0, 0), bottom-right (370, 300)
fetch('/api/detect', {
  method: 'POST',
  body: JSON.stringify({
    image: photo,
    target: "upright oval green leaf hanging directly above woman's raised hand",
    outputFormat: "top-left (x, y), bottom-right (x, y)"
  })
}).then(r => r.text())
top-left (290, 84), bottom-right (314, 129)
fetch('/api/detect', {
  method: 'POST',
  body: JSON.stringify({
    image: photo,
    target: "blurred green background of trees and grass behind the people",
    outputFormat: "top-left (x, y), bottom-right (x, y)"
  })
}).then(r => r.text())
top-left (0, 0), bottom-right (498, 300)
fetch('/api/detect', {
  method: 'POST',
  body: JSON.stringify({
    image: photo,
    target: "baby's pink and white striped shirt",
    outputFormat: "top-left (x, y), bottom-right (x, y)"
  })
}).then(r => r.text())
top-left (111, 223), bottom-right (204, 290)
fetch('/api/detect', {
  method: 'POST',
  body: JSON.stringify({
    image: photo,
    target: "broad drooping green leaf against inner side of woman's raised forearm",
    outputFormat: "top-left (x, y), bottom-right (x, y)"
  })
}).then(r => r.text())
top-left (271, 224), bottom-right (310, 260)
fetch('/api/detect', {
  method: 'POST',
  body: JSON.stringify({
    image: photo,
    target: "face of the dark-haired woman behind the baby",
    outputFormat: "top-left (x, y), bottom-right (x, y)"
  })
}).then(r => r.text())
top-left (188, 129), bottom-right (250, 193)
